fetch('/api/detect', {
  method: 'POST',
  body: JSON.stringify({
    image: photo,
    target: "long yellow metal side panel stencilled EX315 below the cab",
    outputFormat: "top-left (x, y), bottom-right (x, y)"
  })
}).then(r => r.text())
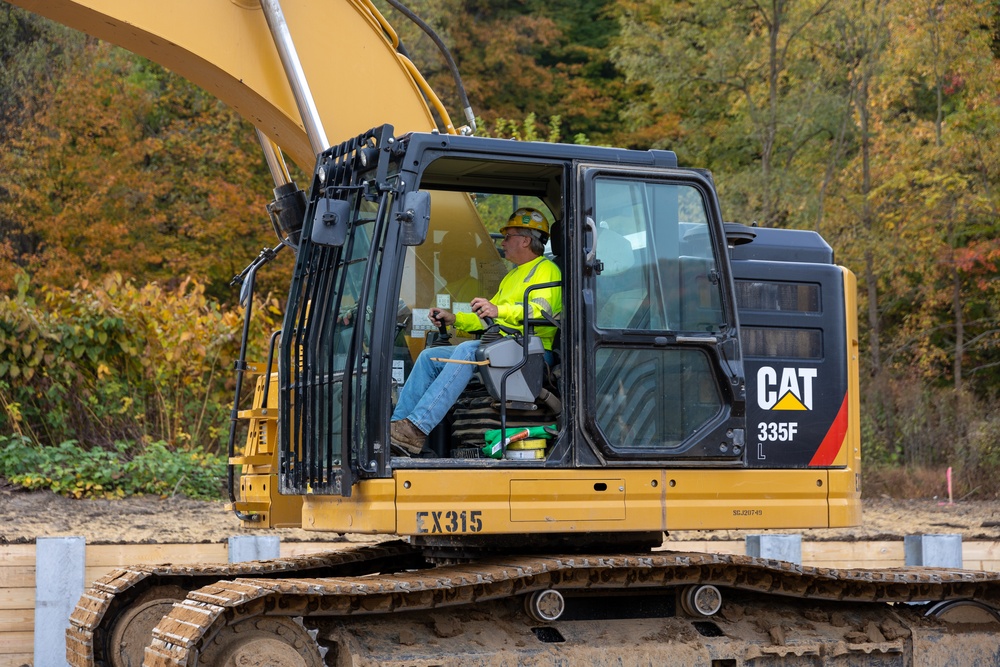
top-left (278, 468), bottom-right (860, 535)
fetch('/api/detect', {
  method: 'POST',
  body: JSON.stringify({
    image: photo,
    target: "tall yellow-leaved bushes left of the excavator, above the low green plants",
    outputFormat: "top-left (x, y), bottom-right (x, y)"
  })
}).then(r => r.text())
top-left (0, 274), bottom-right (277, 451)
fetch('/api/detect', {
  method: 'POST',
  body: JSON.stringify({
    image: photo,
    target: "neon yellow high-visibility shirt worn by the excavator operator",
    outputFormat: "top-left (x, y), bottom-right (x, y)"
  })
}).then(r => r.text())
top-left (455, 257), bottom-right (562, 350)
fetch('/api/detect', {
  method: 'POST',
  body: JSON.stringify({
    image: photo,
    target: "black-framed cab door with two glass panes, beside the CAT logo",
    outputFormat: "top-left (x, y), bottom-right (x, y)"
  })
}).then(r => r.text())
top-left (577, 165), bottom-right (745, 465)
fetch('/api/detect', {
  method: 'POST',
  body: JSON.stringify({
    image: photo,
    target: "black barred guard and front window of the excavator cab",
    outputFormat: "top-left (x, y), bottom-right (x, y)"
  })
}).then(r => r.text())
top-left (278, 126), bottom-right (400, 496)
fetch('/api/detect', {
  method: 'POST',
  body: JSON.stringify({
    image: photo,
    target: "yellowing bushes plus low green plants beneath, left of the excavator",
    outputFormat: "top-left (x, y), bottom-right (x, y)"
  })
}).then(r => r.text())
top-left (0, 274), bottom-right (279, 498)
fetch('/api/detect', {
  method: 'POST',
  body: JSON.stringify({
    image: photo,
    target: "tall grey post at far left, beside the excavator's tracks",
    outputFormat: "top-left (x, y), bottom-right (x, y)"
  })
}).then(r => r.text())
top-left (34, 537), bottom-right (87, 667)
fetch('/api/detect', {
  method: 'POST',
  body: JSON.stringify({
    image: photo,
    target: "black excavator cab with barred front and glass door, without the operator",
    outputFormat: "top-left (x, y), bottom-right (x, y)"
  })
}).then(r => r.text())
top-left (278, 126), bottom-right (745, 504)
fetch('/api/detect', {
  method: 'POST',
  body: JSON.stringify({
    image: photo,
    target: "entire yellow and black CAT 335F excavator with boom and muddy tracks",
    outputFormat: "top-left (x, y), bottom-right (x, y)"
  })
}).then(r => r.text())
top-left (7, 0), bottom-right (1000, 667)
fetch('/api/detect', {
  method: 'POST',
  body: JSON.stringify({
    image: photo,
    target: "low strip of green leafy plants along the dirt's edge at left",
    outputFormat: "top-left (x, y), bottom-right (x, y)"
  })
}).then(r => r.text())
top-left (0, 435), bottom-right (226, 500)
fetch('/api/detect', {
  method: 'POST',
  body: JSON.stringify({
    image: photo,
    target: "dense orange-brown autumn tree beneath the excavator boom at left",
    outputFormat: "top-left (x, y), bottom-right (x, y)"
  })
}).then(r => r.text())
top-left (0, 28), bottom-right (292, 300)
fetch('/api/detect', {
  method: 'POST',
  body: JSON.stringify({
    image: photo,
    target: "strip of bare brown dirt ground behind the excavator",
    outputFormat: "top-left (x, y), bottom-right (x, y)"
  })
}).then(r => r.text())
top-left (0, 485), bottom-right (1000, 544)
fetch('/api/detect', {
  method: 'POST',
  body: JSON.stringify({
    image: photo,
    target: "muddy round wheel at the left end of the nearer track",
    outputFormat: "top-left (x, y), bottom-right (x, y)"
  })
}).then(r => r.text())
top-left (198, 616), bottom-right (325, 667)
